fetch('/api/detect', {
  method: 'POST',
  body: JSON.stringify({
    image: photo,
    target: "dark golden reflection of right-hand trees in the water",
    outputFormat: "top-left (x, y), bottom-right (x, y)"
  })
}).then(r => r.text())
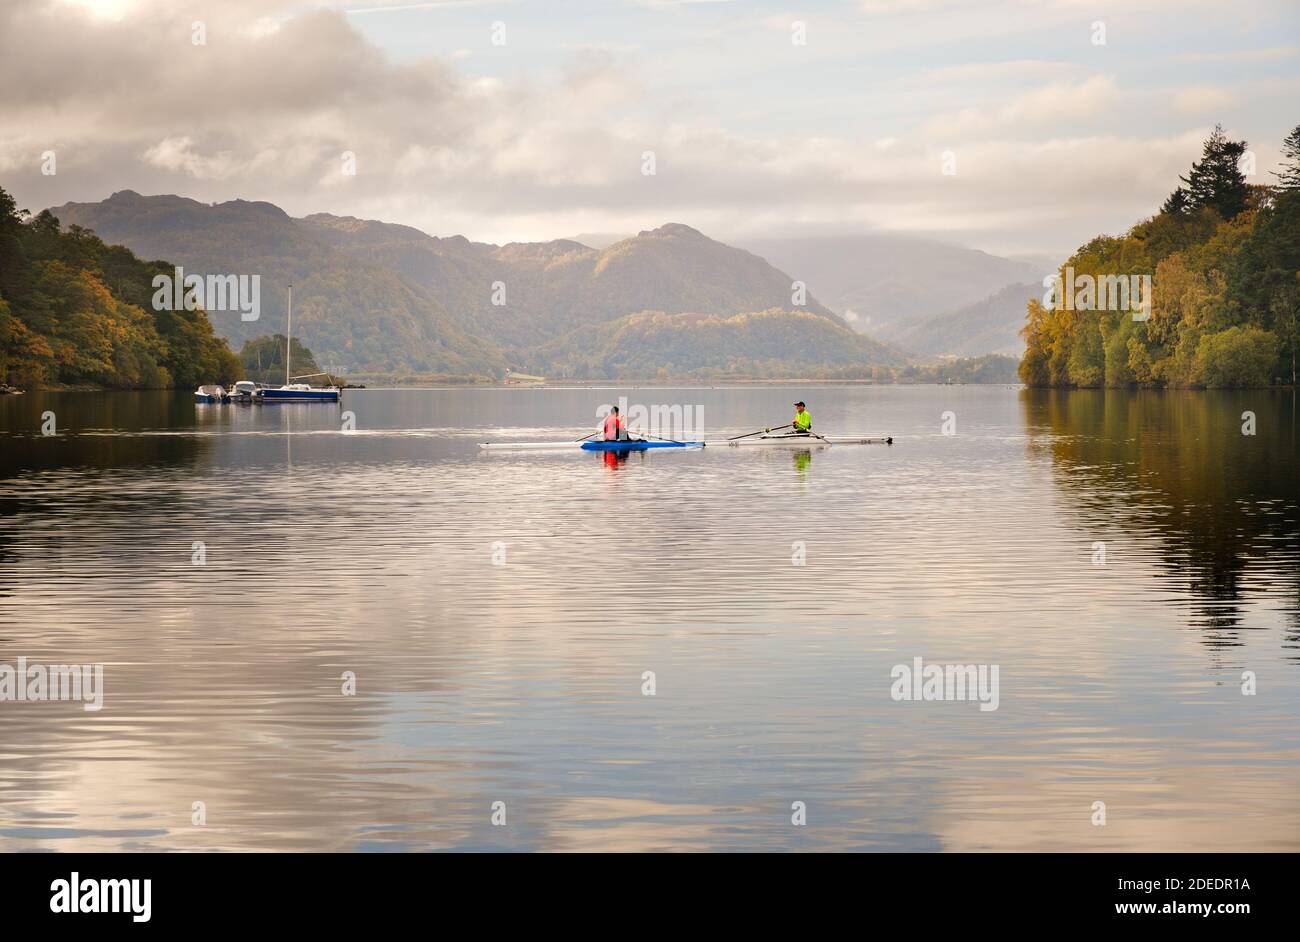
top-left (1022, 390), bottom-right (1300, 647)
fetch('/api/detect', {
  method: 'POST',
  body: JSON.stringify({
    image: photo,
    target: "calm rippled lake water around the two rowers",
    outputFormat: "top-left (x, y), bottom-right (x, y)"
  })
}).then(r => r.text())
top-left (0, 386), bottom-right (1300, 851)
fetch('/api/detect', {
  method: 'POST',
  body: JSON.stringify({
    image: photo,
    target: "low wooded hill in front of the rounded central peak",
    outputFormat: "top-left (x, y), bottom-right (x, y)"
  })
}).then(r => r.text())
top-left (533, 308), bottom-right (905, 379)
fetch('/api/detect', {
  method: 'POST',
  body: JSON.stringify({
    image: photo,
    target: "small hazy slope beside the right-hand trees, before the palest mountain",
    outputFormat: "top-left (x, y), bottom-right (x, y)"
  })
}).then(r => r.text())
top-left (894, 282), bottom-right (1044, 359)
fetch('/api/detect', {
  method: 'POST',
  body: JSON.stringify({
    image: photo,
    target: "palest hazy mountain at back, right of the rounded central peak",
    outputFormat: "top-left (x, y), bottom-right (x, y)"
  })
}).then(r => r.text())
top-left (742, 235), bottom-right (1048, 343)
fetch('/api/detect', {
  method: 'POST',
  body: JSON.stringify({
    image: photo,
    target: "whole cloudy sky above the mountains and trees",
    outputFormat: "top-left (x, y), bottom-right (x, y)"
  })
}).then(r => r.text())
top-left (0, 0), bottom-right (1300, 257)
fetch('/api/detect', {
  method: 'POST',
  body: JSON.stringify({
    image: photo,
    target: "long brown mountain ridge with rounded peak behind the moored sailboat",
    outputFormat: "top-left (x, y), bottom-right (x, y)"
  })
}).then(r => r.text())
top-left (52, 191), bottom-right (847, 374)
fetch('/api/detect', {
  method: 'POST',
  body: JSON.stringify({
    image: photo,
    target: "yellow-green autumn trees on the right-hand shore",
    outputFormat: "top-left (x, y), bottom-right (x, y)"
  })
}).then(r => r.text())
top-left (1019, 127), bottom-right (1300, 387)
